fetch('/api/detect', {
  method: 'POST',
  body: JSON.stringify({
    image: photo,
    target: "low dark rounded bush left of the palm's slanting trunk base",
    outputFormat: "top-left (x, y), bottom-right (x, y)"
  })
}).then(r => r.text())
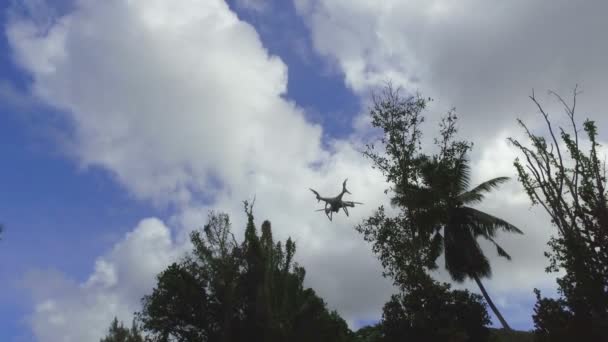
top-left (379, 284), bottom-right (490, 342)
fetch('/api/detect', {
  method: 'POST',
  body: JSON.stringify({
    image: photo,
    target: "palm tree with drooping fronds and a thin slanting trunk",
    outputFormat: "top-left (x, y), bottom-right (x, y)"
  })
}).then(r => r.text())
top-left (392, 157), bottom-right (523, 330)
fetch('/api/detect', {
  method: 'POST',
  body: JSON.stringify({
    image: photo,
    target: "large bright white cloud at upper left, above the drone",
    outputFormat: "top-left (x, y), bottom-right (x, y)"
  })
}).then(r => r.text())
top-left (8, 0), bottom-right (322, 203)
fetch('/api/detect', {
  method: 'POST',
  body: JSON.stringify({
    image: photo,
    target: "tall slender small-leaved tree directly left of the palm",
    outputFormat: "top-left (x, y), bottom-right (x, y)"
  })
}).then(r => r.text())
top-left (356, 84), bottom-right (439, 291)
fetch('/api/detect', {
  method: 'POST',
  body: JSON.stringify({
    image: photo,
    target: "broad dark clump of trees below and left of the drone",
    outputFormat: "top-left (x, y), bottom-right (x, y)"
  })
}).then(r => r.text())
top-left (138, 202), bottom-right (352, 342)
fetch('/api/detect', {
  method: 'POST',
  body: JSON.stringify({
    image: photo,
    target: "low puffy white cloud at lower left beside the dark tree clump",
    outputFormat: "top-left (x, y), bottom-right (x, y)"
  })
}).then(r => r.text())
top-left (25, 218), bottom-right (181, 342)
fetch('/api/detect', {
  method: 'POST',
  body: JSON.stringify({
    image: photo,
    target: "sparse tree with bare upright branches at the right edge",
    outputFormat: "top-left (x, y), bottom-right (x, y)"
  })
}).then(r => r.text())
top-left (509, 87), bottom-right (608, 341)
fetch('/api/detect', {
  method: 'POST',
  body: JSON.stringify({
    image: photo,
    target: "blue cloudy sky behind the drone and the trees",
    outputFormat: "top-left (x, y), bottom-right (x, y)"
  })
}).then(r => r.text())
top-left (0, 0), bottom-right (608, 341)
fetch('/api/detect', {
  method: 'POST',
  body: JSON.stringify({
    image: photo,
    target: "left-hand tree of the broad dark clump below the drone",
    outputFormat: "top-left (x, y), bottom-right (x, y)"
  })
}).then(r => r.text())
top-left (138, 212), bottom-right (242, 341)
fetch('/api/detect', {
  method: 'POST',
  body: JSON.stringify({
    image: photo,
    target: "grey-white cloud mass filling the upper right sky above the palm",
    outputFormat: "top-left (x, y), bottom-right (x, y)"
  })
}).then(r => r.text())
top-left (294, 0), bottom-right (608, 139)
